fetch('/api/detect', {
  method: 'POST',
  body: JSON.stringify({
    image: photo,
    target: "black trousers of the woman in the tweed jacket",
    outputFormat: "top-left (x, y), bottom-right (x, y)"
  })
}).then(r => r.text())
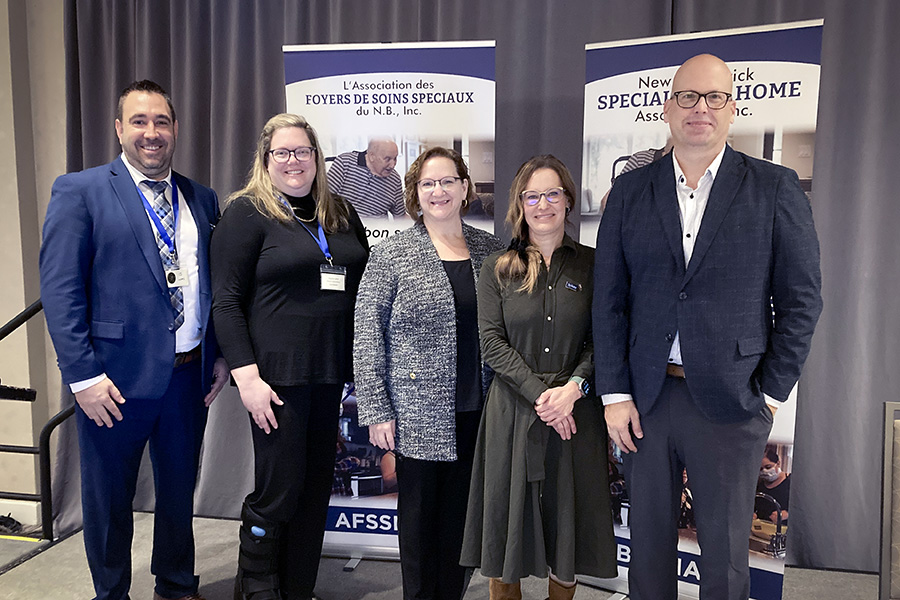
top-left (397, 411), bottom-right (481, 600)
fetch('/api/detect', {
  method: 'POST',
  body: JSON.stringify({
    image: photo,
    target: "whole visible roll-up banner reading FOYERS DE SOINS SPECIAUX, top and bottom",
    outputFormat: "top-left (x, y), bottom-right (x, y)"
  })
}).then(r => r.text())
top-left (283, 41), bottom-right (502, 558)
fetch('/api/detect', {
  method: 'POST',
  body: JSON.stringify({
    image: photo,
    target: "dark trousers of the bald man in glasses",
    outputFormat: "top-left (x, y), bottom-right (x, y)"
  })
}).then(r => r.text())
top-left (624, 377), bottom-right (772, 600)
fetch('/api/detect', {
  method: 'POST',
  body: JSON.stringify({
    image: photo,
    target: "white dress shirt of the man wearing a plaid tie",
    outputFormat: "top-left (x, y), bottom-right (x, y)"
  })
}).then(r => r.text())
top-left (69, 153), bottom-right (203, 393)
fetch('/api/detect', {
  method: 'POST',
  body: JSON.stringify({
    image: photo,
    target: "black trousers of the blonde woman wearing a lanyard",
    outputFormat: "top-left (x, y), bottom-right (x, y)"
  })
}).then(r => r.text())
top-left (245, 384), bottom-right (343, 600)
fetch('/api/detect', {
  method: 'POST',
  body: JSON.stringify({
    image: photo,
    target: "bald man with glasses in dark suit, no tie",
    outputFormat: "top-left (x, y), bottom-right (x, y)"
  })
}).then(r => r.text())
top-left (593, 54), bottom-right (822, 600)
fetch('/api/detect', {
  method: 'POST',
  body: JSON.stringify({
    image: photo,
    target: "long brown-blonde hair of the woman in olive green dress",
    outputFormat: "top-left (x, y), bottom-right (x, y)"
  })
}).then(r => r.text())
top-left (494, 154), bottom-right (575, 294)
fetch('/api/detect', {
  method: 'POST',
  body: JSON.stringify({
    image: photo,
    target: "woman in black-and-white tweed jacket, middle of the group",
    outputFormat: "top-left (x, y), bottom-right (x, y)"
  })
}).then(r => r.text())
top-left (353, 148), bottom-right (502, 600)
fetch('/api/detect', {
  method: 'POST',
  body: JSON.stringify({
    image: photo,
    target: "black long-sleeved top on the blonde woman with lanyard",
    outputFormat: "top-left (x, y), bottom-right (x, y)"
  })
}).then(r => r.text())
top-left (210, 195), bottom-right (369, 385)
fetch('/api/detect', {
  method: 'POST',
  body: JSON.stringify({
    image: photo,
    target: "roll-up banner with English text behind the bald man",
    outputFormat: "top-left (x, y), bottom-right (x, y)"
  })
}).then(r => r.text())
top-left (581, 20), bottom-right (823, 600)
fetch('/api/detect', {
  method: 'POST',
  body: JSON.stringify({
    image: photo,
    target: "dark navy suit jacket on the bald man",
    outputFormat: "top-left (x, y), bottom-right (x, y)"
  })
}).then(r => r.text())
top-left (593, 147), bottom-right (822, 423)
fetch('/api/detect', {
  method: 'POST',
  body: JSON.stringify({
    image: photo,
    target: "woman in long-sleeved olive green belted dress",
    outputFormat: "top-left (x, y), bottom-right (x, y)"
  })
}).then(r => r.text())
top-left (461, 155), bottom-right (616, 600)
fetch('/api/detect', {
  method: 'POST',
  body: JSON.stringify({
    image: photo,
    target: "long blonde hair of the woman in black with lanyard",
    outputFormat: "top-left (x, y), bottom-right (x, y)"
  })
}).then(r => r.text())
top-left (225, 113), bottom-right (350, 233)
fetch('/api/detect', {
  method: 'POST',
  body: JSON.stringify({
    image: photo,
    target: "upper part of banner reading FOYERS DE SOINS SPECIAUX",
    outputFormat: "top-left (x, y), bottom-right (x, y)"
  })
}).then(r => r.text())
top-left (283, 41), bottom-right (496, 244)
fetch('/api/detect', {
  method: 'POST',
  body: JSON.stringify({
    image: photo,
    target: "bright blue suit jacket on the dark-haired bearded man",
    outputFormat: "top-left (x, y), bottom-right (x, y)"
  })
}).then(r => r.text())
top-left (40, 157), bottom-right (219, 399)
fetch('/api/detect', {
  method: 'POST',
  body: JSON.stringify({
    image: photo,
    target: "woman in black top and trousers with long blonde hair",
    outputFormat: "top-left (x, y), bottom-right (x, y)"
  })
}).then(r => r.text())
top-left (210, 114), bottom-right (369, 600)
